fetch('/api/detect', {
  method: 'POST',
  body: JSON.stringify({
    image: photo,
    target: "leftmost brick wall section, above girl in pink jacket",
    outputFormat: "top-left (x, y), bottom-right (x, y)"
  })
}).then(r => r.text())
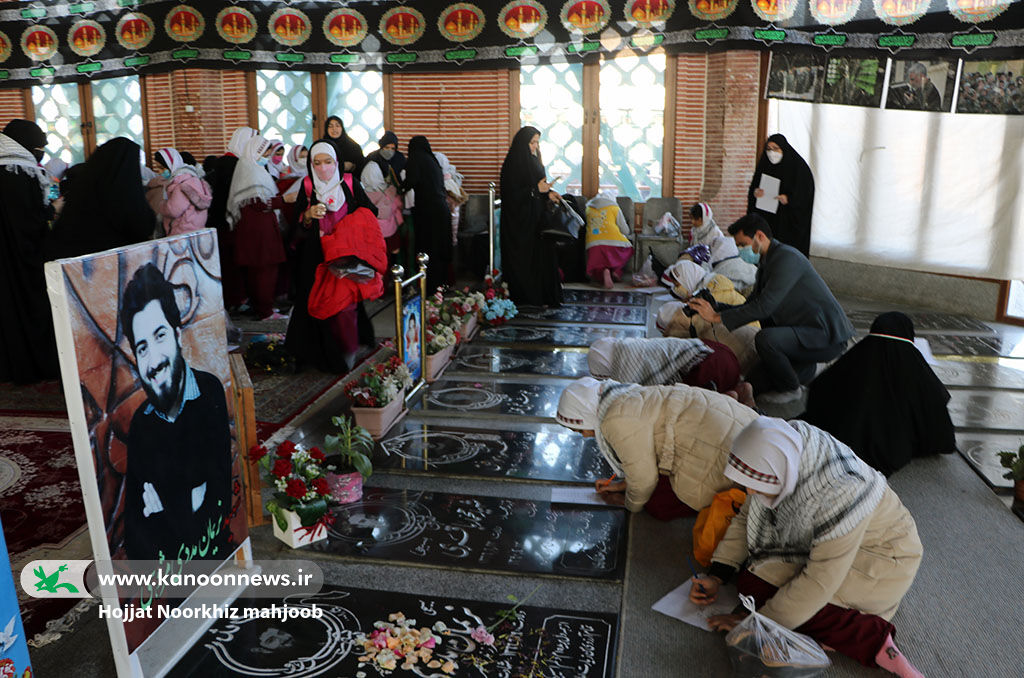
top-left (143, 69), bottom-right (249, 162)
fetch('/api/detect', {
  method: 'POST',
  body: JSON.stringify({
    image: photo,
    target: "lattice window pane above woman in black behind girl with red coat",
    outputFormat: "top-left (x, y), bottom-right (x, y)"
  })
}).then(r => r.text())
top-left (327, 71), bottom-right (385, 153)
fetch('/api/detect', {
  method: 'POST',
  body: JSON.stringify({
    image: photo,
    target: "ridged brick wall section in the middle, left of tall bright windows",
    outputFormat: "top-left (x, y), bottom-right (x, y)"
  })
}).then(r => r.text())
top-left (391, 70), bottom-right (515, 194)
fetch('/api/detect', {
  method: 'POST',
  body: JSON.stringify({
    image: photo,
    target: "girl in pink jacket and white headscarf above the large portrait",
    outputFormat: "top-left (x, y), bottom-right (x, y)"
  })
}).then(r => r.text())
top-left (146, 149), bottom-right (212, 237)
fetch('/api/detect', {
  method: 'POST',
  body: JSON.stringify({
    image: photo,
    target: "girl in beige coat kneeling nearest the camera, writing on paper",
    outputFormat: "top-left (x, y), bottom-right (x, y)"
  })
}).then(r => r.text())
top-left (690, 417), bottom-right (923, 678)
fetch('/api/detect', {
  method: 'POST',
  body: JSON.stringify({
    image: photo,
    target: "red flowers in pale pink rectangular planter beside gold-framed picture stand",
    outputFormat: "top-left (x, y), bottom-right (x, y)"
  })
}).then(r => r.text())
top-left (345, 355), bottom-right (413, 440)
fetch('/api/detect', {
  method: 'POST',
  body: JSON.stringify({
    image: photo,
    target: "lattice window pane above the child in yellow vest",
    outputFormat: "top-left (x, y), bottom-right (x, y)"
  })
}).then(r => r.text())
top-left (598, 53), bottom-right (665, 202)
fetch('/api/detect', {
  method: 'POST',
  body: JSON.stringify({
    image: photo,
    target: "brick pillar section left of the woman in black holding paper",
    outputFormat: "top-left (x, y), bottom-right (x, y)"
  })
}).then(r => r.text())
top-left (674, 50), bottom-right (760, 228)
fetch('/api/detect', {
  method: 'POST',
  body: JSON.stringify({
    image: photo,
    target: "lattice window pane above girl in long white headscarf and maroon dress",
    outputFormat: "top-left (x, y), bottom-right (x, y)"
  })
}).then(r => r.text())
top-left (256, 71), bottom-right (318, 146)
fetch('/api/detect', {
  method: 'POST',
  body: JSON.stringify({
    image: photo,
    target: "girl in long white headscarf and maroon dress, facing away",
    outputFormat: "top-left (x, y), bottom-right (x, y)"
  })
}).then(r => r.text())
top-left (226, 135), bottom-right (285, 320)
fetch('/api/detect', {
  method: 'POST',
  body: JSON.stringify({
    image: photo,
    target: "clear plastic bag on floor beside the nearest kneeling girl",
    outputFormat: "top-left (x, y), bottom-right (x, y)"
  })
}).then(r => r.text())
top-left (725, 595), bottom-right (831, 678)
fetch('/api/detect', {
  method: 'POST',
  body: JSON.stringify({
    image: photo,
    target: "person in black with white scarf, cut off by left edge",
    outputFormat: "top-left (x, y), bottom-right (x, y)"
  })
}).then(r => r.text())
top-left (0, 120), bottom-right (58, 383)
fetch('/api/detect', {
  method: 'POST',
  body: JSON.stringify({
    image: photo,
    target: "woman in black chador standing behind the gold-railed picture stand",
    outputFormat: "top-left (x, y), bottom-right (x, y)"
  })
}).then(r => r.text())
top-left (401, 136), bottom-right (453, 292)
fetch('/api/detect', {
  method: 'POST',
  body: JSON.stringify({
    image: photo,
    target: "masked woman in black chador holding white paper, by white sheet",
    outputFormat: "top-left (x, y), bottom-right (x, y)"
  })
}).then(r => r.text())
top-left (746, 134), bottom-right (814, 257)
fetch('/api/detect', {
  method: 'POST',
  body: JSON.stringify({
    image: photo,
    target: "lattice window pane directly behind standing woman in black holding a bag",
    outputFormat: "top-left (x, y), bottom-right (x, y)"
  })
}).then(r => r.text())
top-left (519, 63), bottom-right (584, 196)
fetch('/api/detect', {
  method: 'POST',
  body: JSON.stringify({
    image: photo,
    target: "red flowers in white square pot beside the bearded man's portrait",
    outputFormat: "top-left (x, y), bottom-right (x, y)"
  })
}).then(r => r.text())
top-left (250, 440), bottom-right (334, 549)
